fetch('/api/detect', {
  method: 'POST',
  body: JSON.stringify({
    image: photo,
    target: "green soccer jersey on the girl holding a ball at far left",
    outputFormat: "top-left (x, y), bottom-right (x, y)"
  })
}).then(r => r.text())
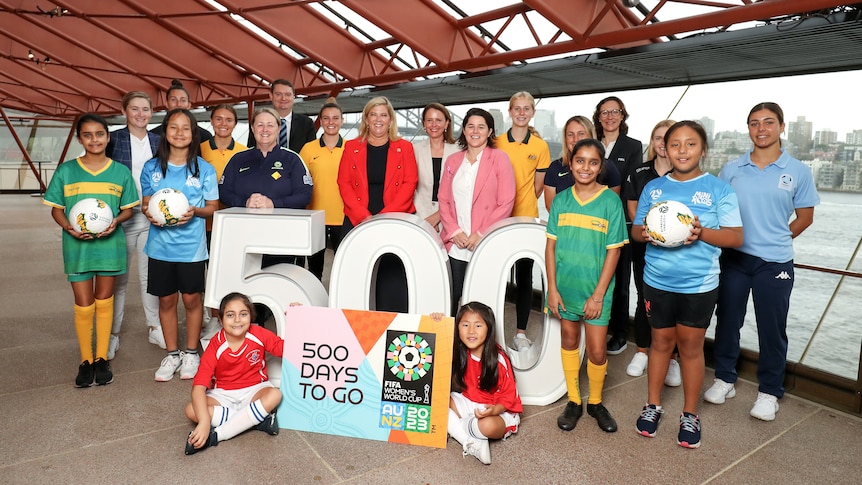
top-left (42, 159), bottom-right (141, 275)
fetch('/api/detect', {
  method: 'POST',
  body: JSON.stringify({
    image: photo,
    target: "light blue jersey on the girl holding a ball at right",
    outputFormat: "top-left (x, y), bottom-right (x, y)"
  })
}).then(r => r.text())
top-left (634, 172), bottom-right (742, 294)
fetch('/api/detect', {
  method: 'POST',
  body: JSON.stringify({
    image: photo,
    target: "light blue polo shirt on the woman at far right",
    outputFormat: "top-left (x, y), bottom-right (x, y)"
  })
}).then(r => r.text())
top-left (718, 149), bottom-right (820, 263)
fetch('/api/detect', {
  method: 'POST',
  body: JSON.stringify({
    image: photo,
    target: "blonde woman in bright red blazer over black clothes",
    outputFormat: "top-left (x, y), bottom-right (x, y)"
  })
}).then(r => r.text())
top-left (338, 96), bottom-right (419, 313)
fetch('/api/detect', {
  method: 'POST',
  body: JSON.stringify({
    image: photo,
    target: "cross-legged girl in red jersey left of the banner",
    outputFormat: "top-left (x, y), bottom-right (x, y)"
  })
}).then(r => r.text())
top-left (186, 293), bottom-right (284, 455)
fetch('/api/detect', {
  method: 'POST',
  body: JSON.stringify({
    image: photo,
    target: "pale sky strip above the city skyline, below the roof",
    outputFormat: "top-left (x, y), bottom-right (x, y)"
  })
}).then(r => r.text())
top-left (472, 71), bottom-right (862, 146)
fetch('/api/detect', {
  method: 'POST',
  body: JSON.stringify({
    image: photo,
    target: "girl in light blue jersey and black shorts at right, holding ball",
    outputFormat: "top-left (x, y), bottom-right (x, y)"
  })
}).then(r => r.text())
top-left (632, 121), bottom-right (743, 448)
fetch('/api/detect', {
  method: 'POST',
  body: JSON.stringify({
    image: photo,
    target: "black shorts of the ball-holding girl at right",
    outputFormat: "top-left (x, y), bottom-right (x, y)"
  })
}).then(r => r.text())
top-left (643, 283), bottom-right (718, 328)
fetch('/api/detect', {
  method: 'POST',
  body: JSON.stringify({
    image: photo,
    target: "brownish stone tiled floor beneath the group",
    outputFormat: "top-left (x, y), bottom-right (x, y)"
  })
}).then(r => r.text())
top-left (0, 195), bottom-right (862, 484)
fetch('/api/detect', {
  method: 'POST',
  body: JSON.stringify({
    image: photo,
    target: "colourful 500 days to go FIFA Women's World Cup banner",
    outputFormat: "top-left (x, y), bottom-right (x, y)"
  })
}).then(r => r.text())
top-left (278, 306), bottom-right (454, 448)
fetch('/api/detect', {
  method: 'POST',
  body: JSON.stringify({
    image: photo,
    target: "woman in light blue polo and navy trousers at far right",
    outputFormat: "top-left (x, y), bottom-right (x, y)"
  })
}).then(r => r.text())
top-left (703, 103), bottom-right (820, 421)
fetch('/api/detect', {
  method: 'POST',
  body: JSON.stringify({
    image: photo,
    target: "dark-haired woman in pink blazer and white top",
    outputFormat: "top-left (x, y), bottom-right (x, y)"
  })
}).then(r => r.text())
top-left (437, 108), bottom-right (515, 316)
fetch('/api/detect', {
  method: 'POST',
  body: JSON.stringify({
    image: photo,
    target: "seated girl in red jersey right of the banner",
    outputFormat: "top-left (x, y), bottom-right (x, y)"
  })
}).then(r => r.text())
top-left (447, 301), bottom-right (524, 465)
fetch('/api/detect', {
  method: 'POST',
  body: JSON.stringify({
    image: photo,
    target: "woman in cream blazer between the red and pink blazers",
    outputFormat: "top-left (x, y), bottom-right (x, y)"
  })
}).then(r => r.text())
top-left (413, 103), bottom-right (459, 232)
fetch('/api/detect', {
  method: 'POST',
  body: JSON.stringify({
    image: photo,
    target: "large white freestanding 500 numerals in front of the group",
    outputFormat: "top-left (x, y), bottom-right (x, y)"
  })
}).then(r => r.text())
top-left (205, 208), bottom-right (584, 405)
